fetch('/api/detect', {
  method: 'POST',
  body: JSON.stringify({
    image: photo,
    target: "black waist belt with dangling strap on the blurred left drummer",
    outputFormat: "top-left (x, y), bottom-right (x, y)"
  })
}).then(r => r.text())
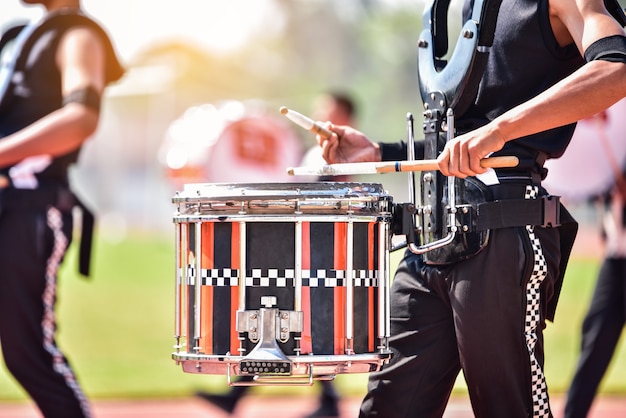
top-left (0, 186), bottom-right (95, 277)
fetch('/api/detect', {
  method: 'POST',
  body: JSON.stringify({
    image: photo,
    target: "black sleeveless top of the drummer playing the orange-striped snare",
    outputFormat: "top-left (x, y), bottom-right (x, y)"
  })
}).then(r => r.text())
top-left (381, 0), bottom-right (584, 175)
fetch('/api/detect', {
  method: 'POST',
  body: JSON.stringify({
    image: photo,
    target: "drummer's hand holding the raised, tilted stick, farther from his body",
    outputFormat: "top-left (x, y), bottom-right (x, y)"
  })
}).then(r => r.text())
top-left (316, 123), bottom-right (381, 164)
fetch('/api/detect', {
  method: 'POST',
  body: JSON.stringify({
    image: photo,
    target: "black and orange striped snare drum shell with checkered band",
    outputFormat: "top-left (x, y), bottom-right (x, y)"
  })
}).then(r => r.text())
top-left (174, 183), bottom-right (390, 362)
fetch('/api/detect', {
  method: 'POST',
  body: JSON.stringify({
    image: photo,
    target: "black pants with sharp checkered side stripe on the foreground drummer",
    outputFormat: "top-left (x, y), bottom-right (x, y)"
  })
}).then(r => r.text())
top-left (360, 227), bottom-right (560, 418)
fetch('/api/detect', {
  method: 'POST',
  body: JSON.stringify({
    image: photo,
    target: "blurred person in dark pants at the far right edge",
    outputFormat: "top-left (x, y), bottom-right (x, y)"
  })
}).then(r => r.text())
top-left (564, 112), bottom-right (626, 418)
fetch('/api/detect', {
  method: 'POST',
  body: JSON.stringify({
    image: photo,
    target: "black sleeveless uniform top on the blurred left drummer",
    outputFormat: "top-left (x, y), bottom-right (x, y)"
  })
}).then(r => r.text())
top-left (0, 10), bottom-right (124, 185)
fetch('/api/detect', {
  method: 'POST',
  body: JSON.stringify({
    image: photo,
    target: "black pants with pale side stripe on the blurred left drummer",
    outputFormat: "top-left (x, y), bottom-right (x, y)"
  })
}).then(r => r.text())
top-left (0, 202), bottom-right (89, 418)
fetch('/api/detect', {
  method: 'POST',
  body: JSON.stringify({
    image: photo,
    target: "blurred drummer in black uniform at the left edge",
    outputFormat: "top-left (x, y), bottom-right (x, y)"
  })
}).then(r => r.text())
top-left (0, 0), bottom-right (124, 418)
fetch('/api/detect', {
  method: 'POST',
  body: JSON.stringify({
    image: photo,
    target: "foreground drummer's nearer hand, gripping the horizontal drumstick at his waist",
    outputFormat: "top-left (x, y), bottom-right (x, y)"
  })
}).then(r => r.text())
top-left (437, 125), bottom-right (505, 178)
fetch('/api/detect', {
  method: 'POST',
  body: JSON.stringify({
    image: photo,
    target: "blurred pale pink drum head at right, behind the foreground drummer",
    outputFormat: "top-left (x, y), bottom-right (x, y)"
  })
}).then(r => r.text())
top-left (543, 99), bottom-right (626, 203)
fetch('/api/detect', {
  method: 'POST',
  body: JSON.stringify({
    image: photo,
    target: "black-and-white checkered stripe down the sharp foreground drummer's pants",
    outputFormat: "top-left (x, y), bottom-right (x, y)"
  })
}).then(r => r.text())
top-left (524, 186), bottom-right (550, 417)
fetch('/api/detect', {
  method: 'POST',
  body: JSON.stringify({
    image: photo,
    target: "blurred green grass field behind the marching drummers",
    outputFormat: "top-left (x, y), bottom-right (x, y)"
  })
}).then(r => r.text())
top-left (0, 234), bottom-right (626, 400)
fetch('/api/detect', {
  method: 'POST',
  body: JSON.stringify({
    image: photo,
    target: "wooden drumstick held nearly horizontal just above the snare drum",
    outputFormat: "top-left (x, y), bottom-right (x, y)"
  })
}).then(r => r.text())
top-left (287, 156), bottom-right (519, 176)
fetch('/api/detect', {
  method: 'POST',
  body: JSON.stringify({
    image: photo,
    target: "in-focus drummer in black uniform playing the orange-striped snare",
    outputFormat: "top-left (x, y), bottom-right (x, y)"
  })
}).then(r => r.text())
top-left (317, 0), bottom-right (626, 418)
